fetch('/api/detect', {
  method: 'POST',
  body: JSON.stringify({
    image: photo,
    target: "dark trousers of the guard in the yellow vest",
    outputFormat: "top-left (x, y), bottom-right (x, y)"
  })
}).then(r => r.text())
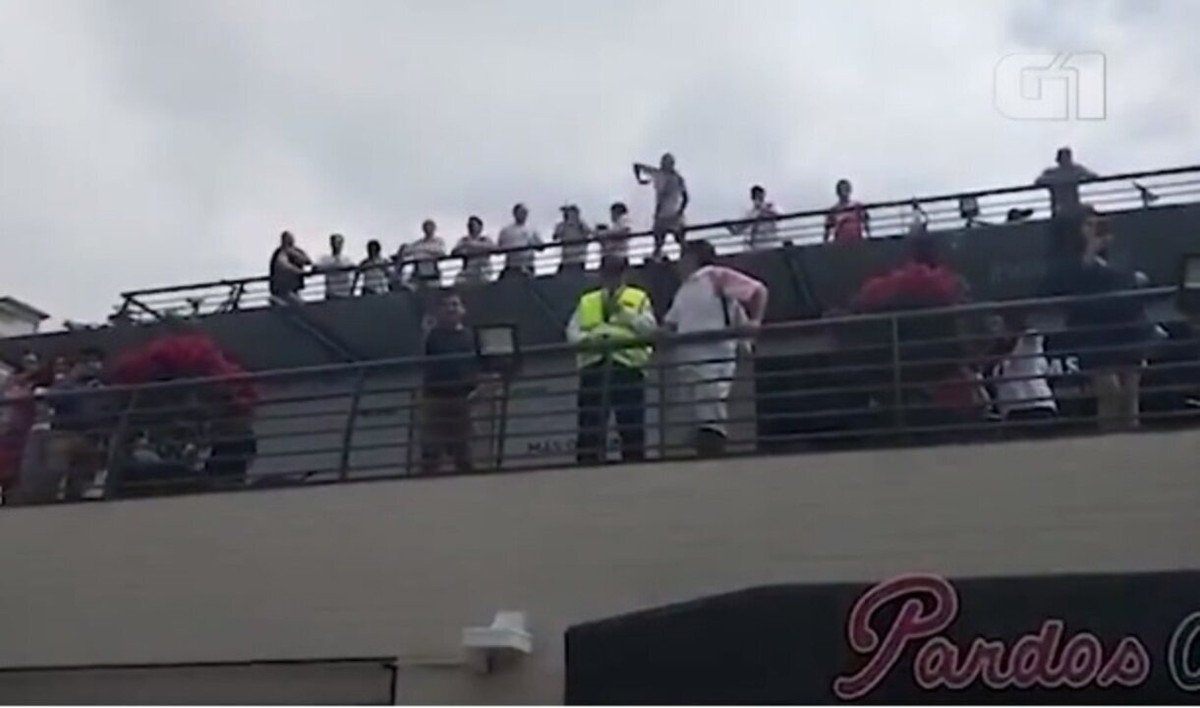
top-left (575, 361), bottom-right (646, 463)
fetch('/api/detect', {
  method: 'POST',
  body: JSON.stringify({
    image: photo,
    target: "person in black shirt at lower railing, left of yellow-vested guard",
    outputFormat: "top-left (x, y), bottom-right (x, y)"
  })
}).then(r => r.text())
top-left (420, 292), bottom-right (479, 474)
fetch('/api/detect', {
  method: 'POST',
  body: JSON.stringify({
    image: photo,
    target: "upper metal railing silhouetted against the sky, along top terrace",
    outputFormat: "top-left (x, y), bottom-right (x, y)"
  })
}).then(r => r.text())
top-left (119, 166), bottom-right (1200, 320)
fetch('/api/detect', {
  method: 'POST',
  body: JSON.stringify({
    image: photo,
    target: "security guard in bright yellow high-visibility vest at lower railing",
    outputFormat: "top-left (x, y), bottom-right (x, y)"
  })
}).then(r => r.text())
top-left (566, 256), bottom-right (658, 463)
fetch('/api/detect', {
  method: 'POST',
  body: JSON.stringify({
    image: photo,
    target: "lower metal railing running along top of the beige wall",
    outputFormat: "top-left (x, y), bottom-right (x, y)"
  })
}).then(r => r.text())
top-left (6, 288), bottom-right (1200, 504)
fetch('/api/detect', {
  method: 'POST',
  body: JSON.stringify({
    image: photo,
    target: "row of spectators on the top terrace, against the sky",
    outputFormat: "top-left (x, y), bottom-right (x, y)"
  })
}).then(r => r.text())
top-left (269, 148), bottom-right (1098, 300)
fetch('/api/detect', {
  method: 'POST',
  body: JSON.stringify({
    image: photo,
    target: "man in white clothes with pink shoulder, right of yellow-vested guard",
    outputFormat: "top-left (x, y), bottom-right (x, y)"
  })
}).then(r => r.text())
top-left (664, 240), bottom-right (768, 456)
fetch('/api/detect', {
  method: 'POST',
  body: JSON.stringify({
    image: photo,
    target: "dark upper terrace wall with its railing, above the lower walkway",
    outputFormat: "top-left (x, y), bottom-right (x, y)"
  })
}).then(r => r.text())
top-left (0, 168), bottom-right (1200, 371)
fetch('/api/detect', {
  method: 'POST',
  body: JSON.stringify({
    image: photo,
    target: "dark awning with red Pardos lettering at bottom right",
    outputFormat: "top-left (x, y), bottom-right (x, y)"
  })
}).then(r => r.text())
top-left (566, 572), bottom-right (1200, 704)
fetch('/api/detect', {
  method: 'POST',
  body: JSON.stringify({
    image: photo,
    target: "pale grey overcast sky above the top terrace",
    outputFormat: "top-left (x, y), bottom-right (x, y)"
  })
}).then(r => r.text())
top-left (0, 0), bottom-right (1200, 319)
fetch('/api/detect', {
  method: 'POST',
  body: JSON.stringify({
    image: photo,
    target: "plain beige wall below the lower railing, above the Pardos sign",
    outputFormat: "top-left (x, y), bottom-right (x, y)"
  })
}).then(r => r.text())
top-left (0, 432), bottom-right (1200, 702)
